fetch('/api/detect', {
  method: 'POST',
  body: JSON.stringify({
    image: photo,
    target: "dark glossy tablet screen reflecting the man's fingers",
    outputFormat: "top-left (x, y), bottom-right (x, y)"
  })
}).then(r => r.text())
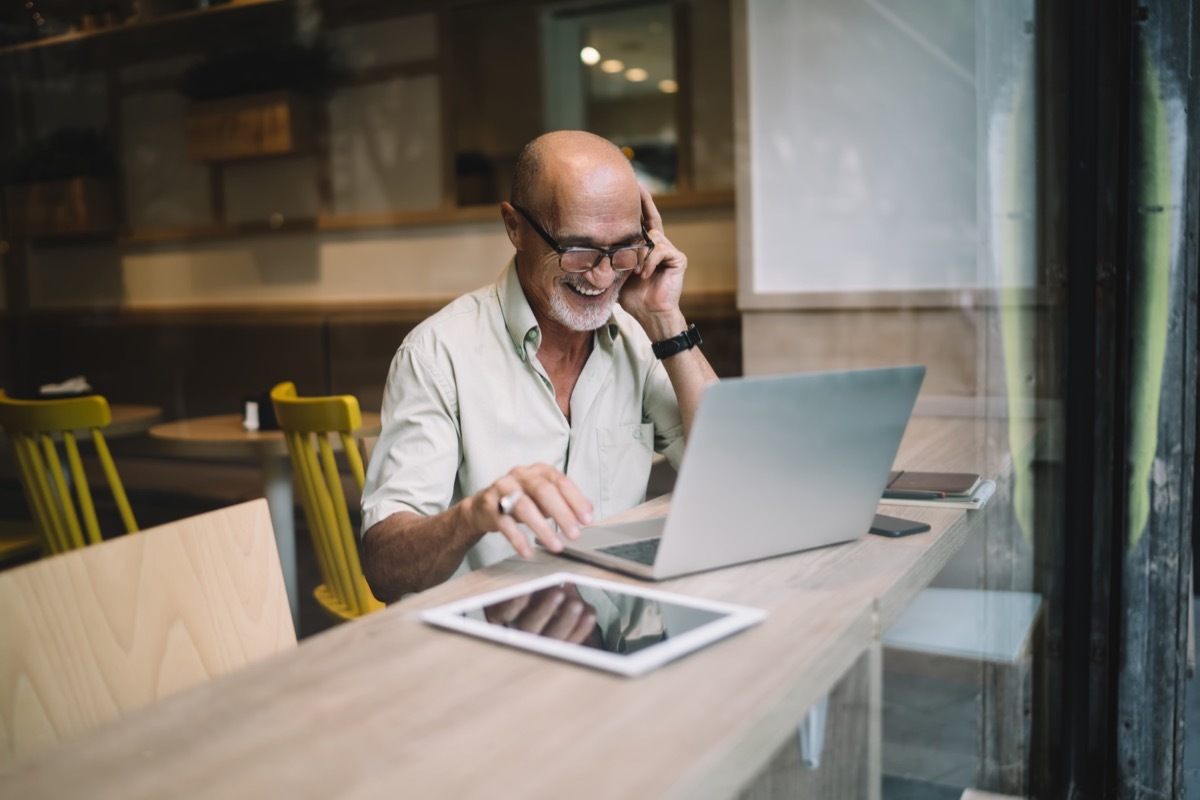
top-left (484, 583), bottom-right (724, 655)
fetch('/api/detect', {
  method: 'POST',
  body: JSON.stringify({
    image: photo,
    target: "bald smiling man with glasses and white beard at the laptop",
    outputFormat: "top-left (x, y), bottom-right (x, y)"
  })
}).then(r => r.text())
top-left (362, 131), bottom-right (716, 601)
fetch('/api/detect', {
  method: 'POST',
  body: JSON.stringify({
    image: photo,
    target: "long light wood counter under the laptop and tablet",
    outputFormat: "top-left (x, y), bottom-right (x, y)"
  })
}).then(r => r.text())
top-left (0, 419), bottom-right (1004, 799)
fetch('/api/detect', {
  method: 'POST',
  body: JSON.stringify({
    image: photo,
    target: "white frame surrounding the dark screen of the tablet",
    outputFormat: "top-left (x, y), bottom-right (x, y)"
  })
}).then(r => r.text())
top-left (420, 572), bottom-right (767, 678)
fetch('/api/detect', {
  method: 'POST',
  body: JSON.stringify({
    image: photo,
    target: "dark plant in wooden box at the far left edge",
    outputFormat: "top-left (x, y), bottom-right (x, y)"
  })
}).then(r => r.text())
top-left (4, 128), bottom-right (118, 236)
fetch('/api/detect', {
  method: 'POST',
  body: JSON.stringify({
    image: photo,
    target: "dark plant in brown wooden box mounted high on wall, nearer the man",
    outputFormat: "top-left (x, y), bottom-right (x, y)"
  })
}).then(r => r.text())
top-left (180, 42), bottom-right (338, 162)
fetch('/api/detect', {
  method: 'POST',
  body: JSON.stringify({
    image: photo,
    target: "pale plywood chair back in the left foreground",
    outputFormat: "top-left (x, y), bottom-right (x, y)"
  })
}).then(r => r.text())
top-left (0, 499), bottom-right (296, 765)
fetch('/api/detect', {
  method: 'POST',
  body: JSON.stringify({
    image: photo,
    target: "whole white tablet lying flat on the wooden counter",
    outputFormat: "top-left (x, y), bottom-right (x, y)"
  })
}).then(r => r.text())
top-left (421, 572), bottom-right (767, 675)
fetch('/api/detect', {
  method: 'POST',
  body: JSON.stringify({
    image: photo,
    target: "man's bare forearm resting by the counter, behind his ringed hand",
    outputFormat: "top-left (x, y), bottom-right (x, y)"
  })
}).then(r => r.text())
top-left (361, 498), bottom-right (482, 602)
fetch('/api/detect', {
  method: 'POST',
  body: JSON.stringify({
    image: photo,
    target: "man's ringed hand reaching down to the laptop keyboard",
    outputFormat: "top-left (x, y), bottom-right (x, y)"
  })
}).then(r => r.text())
top-left (469, 464), bottom-right (592, 558)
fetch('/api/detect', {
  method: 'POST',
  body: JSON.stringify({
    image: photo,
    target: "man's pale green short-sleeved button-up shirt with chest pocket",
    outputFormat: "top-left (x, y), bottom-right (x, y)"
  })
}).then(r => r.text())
top-left (362, 261), bottom-right (684, 582)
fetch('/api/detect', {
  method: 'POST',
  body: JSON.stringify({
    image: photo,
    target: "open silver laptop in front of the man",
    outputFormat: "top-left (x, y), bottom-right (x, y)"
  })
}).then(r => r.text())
top-left (563, 366), bottom-right (925, 581)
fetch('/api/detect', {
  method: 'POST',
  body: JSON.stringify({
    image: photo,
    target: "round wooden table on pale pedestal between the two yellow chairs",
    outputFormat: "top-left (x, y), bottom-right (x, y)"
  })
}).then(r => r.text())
top-left (150, 411), bottom-right (379, 630)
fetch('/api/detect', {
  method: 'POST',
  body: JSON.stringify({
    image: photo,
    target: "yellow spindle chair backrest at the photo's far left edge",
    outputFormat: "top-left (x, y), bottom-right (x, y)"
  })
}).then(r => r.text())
top-left (0, 391), bottom-right (138, 553)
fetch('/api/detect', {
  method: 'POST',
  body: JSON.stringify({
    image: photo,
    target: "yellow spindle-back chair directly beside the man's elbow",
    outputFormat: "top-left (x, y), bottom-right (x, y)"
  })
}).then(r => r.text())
top-left (271, 381), bottom-right (384, 620)
